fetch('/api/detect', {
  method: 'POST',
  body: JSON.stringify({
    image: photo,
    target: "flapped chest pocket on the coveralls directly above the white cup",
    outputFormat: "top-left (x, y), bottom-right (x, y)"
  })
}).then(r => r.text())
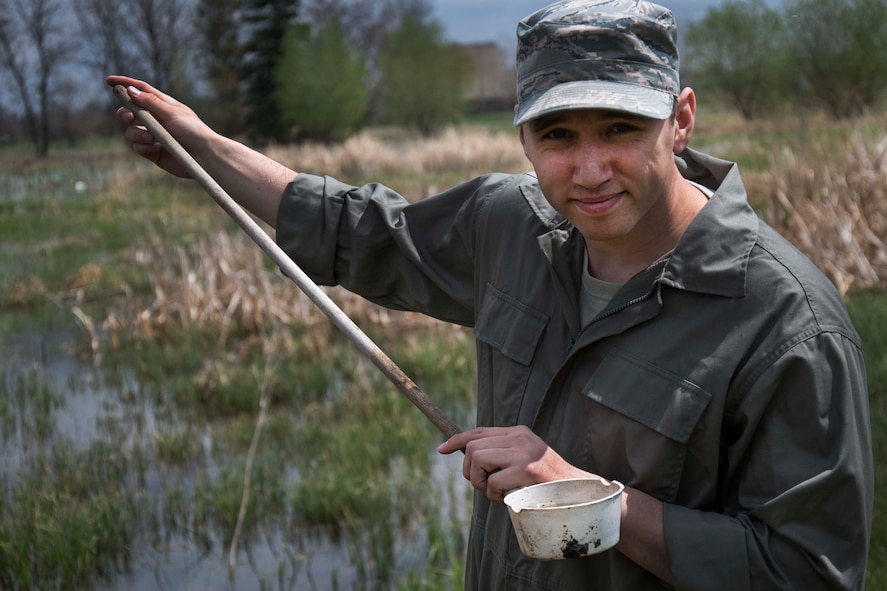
top-left (583, 350), bottom-right (712, 501)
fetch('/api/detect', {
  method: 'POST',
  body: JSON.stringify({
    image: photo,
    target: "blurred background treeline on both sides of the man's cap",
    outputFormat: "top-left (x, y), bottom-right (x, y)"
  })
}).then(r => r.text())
top-left (0, 0), bottom-right (887, 156)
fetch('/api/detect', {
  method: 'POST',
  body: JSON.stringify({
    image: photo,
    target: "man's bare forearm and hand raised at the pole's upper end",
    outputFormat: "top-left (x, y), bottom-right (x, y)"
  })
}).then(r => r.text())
top-left (106, 76), bottom-right (297, 226)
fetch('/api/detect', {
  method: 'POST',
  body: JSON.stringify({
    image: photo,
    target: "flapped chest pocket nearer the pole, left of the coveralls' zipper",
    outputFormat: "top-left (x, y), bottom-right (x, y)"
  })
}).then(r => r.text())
top-left (474, 285), bottom-right (548, 426)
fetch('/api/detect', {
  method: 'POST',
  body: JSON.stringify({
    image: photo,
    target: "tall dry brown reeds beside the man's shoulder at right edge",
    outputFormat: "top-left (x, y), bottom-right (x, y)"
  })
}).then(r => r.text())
top-left (764, 136), bottom-right (887, 293)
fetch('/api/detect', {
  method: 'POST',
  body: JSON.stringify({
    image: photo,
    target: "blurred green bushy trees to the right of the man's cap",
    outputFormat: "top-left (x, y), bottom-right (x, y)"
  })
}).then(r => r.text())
top-left (688, 0), bottom-right (887, 119)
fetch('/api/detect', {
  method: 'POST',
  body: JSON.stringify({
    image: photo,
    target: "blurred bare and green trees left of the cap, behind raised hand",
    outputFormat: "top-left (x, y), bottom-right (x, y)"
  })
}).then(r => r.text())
top-left (0, 0), bottom-right (471, 156)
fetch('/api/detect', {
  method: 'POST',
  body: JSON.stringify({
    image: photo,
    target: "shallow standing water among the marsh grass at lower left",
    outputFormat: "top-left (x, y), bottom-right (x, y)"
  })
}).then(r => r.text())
top-left (0, 316), bottom-right (467, 591)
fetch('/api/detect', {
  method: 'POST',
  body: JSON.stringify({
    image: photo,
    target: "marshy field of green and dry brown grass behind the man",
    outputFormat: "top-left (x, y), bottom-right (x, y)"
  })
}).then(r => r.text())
top-left (0, 113), bottom-right (887, 590)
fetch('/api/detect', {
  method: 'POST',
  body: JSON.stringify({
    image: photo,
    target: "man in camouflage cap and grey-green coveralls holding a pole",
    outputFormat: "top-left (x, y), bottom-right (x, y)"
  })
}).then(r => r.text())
top-left (108, 0), bottom-right (873, 590)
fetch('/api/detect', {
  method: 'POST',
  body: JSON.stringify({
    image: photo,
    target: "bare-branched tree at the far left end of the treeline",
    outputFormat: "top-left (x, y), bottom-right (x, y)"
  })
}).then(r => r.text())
top-left (0, 0), bottom-right (70, 158)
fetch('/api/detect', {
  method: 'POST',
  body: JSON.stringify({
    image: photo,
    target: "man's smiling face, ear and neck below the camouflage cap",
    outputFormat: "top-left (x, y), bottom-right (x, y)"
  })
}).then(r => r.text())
top-left (521, 105), bottom-right (707, 282)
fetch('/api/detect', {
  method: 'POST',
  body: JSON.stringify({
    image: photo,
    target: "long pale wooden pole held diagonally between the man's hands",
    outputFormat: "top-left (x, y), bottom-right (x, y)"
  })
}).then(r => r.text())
top-left (113, 84), bottom-right (460, 439)
